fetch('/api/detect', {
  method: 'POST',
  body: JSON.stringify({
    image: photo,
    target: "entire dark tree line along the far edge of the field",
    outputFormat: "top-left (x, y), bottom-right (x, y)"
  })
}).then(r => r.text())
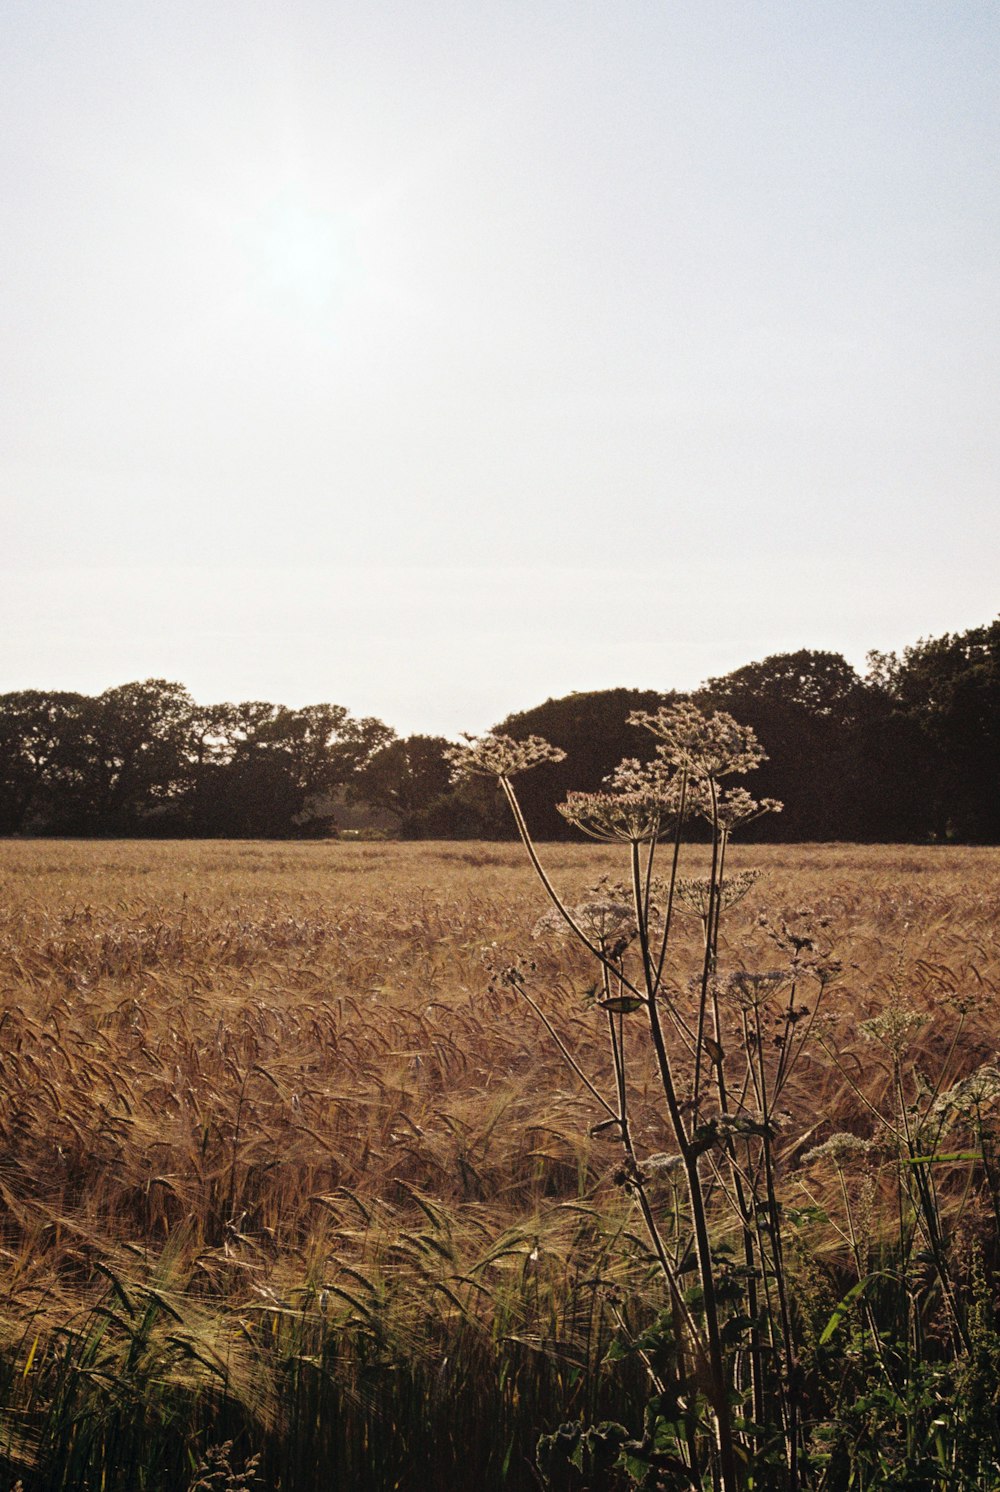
top-left (0, 618), bottom-right (1000, 843)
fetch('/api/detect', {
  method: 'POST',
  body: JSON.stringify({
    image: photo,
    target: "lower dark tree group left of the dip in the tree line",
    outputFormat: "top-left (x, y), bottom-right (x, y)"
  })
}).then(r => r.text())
top-left (0, 679), bottom-right (393, 839)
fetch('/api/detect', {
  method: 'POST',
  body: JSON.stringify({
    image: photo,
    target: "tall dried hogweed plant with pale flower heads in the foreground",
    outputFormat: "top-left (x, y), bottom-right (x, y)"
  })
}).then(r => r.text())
top-left (451, 704), bottom-right (837, 1492)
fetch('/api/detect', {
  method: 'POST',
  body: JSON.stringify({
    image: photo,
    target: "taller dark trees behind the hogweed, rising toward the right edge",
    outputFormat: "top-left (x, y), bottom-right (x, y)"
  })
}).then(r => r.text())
top-left (409, 619), bottom-right (1000, 843)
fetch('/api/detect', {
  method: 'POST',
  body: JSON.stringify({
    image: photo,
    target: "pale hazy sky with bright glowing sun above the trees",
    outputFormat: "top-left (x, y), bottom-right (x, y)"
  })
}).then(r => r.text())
top-left (0, 0), bottom-right (1000, 736)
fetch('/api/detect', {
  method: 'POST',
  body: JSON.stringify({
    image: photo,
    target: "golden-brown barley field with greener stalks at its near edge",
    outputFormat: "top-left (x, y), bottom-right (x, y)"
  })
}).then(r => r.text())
top-left (0, 840), bottom-right (1000, 1492)
